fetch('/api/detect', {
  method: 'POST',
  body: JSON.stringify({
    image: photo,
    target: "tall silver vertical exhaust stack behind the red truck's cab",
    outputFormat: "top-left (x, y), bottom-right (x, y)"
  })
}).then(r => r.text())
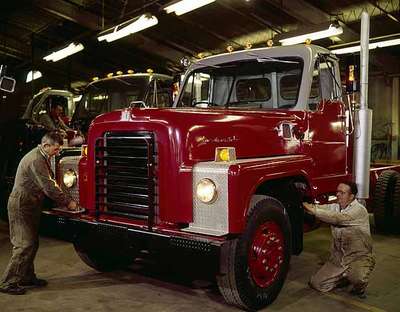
top-left (353, 11), bottom-right (372, 199)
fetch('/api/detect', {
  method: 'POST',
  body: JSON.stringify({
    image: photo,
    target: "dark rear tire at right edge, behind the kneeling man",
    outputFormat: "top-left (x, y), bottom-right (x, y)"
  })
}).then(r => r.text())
top-left (373, 170), bottom-right (400, 233)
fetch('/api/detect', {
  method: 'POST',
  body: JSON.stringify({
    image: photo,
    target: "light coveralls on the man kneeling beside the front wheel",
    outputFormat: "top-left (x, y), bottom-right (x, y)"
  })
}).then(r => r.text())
top-left (310, 200), bottom-right (375, 292)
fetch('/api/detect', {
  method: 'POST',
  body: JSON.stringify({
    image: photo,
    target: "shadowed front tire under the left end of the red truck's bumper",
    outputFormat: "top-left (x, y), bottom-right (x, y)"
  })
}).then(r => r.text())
top-left (74, 240), bottom-right (134, 272)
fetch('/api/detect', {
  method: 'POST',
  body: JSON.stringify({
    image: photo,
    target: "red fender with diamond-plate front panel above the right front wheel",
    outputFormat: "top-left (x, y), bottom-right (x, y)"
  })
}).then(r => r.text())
top-left (186, 155), bottom-right (312, 236)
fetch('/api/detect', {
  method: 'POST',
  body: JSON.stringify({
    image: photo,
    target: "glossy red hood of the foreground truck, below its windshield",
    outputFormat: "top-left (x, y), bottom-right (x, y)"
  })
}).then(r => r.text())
top-left (92, 108), bottom-right (305, 165)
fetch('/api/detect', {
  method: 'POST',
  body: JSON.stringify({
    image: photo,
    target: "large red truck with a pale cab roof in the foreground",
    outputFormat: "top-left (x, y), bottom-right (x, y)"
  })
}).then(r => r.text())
top-left (50, 45), bottom-right (400, 310)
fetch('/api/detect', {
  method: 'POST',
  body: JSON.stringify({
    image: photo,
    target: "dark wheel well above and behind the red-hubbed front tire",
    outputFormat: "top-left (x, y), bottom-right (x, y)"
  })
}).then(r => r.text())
top-left (254, 176), bottom-right (310, 254)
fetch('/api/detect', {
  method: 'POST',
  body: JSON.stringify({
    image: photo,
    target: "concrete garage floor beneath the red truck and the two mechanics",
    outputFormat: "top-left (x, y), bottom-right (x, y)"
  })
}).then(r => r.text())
top-left (0, 221), bottom-right (400, 312)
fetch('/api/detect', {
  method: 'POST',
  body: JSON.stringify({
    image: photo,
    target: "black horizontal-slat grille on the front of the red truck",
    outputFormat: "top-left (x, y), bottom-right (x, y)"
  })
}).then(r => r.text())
top-left (95, 132), bottom-right (156, 225)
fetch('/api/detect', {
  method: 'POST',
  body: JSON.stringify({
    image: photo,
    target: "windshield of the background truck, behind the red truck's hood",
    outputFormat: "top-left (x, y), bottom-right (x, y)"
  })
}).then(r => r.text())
top-left (74, 76), bottom-right (172, 120)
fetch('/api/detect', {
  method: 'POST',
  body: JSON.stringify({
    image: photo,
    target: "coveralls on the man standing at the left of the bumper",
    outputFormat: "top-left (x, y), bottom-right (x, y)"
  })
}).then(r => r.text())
top-left (0, 146), bottom-right (70, 288)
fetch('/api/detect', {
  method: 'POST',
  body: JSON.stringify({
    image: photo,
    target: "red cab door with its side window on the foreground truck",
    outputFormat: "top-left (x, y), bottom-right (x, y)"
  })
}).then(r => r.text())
top-left (305, 56), bottom-right (348, 183)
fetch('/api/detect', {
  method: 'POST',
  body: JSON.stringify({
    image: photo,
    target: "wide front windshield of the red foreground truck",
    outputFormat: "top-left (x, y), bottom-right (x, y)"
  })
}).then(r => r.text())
top-left (177, 57), bottom-right (303, 109)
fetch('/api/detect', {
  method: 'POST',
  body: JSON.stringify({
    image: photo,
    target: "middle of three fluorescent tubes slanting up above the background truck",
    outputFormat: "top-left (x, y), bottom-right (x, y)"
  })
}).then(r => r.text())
top-left (97, 14), bottom-right (158, 42)
